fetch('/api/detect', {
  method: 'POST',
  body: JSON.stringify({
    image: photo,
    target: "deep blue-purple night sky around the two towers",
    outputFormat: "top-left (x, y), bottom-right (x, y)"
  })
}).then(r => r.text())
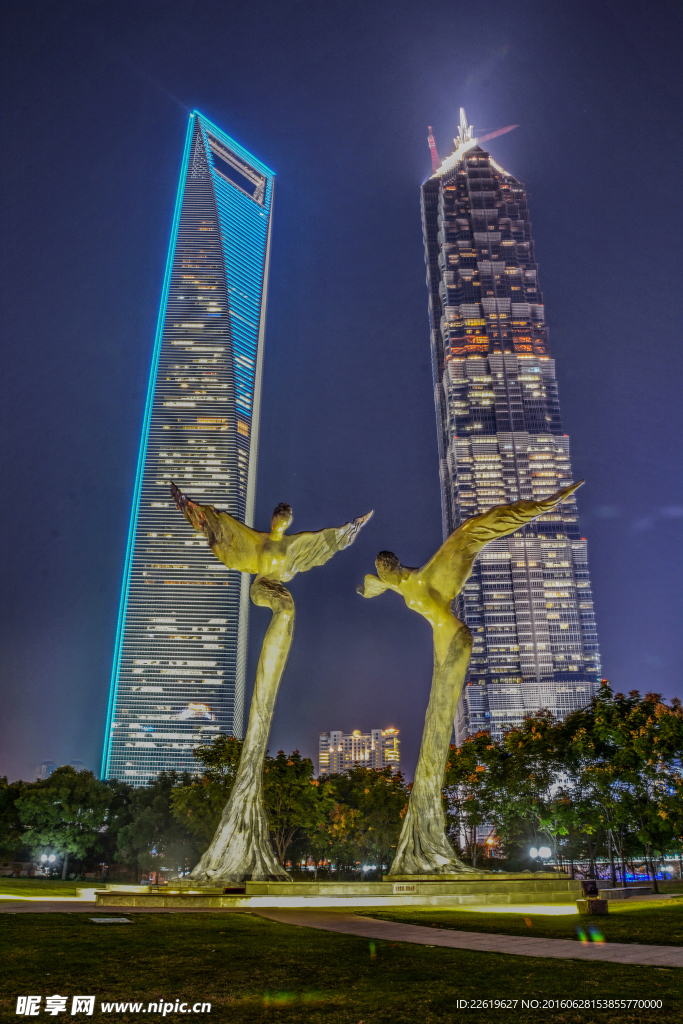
top-left (0, 0), bottom-right (683, 778)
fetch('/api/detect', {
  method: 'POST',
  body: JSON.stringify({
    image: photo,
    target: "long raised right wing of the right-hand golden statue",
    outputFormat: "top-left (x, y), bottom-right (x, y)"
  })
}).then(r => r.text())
top-left (419, 480), bottom-right (584, 601)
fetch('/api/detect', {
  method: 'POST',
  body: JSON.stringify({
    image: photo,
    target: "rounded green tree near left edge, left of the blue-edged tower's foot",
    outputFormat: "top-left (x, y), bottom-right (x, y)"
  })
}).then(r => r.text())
top-left (15, 765), bottom-right (112, 879)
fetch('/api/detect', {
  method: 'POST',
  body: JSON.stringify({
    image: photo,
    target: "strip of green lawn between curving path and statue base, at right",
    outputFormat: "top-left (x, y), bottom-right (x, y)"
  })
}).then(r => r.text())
top-left (364, 899), bottom-right (683, 946)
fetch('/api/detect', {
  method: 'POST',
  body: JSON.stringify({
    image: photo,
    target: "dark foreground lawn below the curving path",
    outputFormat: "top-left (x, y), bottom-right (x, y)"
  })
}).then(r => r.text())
top-left (0, 911), bottom-right (683, 1024)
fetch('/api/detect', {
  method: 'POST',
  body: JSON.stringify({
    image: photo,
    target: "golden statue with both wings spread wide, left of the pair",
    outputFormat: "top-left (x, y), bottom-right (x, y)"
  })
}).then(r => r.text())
top-left (171, 483), bottom-right (373, 885)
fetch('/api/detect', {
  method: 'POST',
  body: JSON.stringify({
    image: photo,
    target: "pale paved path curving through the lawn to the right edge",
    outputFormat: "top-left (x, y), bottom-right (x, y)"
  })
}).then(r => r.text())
top-left (251, 909), bottom-right (683, 968)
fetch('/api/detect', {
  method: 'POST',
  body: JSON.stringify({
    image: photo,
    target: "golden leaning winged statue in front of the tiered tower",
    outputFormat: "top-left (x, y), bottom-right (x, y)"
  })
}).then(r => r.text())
top-left (357, 480), bottom-right (584, 876)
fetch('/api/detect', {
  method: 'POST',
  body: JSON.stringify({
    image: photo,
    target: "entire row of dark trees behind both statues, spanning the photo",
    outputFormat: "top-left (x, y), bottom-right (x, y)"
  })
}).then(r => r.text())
top-left (0, 684), bottom-right (683, 883)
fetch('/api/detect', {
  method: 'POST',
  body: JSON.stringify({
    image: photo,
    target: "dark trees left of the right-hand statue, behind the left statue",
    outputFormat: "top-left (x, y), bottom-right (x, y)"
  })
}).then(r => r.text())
top-left (0, 736), bottom-right (410, 881)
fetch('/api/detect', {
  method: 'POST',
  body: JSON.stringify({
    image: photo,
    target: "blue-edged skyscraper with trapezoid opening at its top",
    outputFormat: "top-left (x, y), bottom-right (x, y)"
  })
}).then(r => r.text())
top-left (102, 113), bottom-right (273, 785)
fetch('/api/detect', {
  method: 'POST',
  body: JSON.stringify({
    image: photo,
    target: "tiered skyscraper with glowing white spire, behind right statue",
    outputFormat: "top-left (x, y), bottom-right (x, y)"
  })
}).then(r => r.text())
top-left (422, 111), bottom-right (600, 741)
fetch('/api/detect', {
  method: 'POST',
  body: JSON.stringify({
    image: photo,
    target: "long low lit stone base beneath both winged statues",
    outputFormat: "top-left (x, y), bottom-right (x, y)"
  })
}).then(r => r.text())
top-left (95, 872), bottom-right (582, 913)
